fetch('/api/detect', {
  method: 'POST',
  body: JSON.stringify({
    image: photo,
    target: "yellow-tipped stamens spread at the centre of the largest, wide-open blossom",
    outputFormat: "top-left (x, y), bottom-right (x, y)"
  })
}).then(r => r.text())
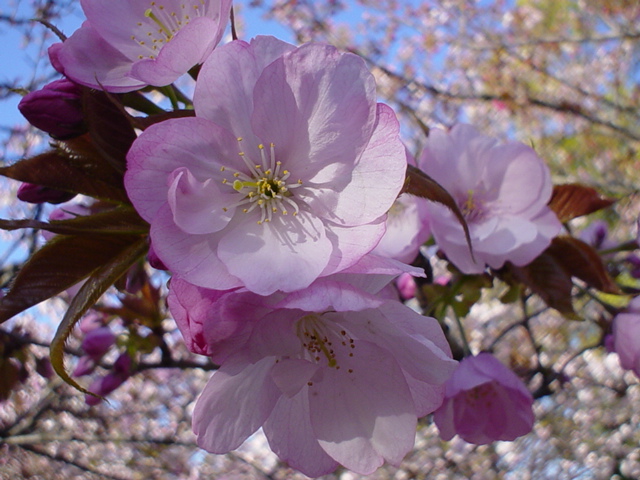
top-left (220, 138), bottom-right (302, 225)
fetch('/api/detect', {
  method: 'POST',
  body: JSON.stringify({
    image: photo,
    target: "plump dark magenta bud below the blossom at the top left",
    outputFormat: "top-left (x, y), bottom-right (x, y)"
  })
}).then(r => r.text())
top-left (18, 79), bottom-right (86, 138)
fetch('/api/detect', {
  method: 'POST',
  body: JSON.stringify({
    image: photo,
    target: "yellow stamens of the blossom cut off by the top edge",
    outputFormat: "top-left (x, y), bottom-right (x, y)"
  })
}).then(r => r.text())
top-left (131, 0), bottom-right (205, 60)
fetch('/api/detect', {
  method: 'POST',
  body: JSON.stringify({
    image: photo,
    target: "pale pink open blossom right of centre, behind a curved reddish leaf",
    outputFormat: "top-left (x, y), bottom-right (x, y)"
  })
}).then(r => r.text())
top-left (418, 125), bottom-right (561, 273)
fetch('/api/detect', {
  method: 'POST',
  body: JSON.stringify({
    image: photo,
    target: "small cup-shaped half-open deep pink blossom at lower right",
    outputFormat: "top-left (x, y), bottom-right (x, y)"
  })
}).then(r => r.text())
top-left (433, 352), bottom-right (534, 445)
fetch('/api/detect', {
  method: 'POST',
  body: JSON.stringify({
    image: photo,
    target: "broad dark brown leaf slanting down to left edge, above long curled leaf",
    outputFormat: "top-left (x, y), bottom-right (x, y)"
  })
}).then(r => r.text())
top-left (0, 235), bottom-right (146, 323)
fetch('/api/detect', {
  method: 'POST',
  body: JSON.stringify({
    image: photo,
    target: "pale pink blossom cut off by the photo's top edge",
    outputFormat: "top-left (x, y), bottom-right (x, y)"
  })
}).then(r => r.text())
top-left (49, 0), bottom-right (231, 92)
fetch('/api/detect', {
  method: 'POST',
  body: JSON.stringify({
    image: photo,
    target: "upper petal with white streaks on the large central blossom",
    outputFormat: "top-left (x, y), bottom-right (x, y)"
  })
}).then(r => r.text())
top-left (252, 44), bottom-right (375, 184)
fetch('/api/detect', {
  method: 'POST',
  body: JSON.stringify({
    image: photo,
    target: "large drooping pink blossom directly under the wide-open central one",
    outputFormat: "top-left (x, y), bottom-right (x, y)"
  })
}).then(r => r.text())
top-left (170, 278), bottom-right (456, 477)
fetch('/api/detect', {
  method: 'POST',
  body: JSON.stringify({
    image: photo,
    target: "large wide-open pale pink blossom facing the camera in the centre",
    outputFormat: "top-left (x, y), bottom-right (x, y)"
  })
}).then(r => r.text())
top-left (125, 37), bottom-right (406, 295)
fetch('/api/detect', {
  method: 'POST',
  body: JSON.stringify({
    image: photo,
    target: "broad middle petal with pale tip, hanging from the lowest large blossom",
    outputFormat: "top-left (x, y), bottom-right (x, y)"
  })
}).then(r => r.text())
top-left (309, 341), bottom-right (416, 475)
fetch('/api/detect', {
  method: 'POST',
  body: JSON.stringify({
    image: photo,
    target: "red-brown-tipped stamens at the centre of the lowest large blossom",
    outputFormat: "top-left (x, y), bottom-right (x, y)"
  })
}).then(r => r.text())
top-left (296, 313), bottom-right (356, 373)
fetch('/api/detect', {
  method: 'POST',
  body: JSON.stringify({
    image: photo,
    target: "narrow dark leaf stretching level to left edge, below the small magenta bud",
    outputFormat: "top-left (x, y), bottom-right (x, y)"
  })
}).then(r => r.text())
top-left (0, 205), bottom-right (149, 235)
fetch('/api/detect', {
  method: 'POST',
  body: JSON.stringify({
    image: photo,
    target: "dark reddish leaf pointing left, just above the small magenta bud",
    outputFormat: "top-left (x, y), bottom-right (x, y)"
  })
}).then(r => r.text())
top-left (0, 150), bottom-right (129, 203)
